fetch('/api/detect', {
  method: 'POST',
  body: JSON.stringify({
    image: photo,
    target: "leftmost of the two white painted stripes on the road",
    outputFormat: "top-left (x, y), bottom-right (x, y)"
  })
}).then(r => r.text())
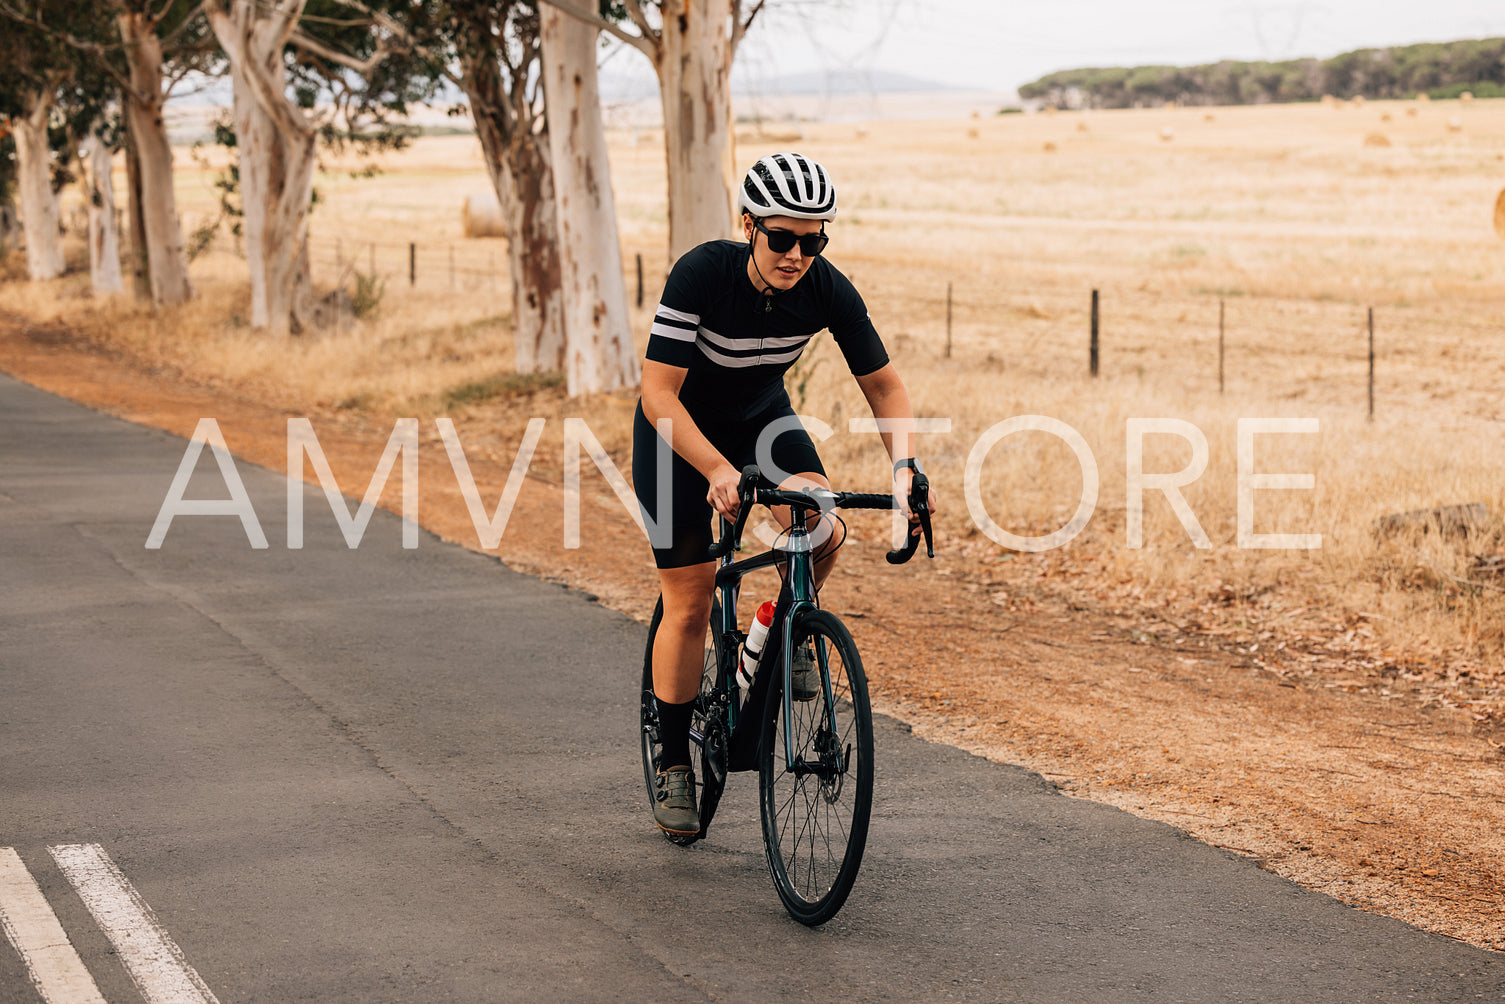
top-left (0, 847), bottom-right (105, 1004)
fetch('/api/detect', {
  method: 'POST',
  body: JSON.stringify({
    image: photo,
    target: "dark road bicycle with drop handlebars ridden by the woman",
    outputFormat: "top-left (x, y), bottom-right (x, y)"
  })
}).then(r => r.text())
top-left (641, 465), bottom-right (935, 926)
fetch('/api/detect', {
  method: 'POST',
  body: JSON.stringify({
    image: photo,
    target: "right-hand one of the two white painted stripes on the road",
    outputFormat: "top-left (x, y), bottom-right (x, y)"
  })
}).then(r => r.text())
top-left (47, 843), bottom-right (218, 1004)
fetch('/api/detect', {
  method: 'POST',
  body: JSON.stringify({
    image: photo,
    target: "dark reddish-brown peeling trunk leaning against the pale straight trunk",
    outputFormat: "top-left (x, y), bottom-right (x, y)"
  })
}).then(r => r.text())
top-left (461, 42), bottom-right (564, 373)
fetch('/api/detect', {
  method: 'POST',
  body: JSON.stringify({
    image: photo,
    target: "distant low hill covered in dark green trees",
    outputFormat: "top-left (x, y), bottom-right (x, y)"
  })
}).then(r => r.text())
top-left (1019, 38), bottom-right (1505, 108)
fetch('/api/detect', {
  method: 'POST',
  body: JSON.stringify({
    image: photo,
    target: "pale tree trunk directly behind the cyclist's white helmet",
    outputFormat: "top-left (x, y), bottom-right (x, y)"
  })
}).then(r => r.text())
top-left (649, 0), bottom-right (737, 265)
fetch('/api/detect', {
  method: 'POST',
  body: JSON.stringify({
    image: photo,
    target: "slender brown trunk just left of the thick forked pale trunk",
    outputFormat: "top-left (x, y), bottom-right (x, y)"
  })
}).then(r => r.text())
top-left (116, 11), bottom-right (193, 306)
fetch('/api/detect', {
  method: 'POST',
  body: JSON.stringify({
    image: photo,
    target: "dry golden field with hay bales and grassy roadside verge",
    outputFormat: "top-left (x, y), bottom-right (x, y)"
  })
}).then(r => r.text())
top-left (0, 94), bottom-right (1505, 948)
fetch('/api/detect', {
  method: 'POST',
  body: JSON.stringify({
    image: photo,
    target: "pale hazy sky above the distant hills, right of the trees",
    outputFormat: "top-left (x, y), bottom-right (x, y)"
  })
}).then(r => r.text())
top-left (737, 0), bottom-right (1505, 90)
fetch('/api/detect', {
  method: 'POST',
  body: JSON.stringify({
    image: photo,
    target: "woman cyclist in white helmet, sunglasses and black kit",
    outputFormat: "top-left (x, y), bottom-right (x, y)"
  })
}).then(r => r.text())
top-left (632, 154), bottom-right (935, 835)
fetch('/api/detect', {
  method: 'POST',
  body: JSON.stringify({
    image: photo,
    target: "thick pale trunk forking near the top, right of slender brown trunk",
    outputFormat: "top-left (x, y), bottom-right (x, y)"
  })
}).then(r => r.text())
top-left (205, 0), bottom-right (318, 334)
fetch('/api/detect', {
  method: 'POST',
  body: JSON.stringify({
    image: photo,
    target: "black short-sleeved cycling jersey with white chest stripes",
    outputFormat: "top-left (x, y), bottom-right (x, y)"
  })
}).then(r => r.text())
top-left (647, 241), bottom-right (888, 421)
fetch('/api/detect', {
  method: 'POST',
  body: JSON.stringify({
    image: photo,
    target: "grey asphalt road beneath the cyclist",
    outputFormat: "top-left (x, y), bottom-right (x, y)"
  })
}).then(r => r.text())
top-left (0, 378), bottom-right (1505, 1002)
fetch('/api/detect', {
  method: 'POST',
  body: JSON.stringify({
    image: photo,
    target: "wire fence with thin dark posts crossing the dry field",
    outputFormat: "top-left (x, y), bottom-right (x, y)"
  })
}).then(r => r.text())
top-left (185, 225), bottom-right (1505, 421)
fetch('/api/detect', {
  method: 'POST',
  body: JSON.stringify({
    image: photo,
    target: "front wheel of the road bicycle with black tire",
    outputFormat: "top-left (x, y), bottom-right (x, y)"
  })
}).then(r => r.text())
top-left (759, 610), bottom-right (873, 927)
